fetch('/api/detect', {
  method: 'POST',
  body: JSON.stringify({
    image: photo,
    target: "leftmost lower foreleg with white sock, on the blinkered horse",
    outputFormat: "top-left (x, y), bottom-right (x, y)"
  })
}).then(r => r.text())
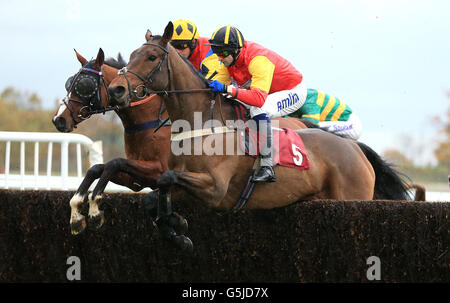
top-left (70, 164), bottom-right (104, 235)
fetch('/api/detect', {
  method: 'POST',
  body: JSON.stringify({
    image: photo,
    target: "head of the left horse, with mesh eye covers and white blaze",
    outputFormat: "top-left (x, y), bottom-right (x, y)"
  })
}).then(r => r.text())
top-left (52, 48), bottom-right (108, 132)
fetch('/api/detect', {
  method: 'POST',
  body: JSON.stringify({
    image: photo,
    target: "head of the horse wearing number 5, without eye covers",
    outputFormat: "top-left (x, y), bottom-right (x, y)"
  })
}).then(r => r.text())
top-left (108, 22), bottom-right (173, 107)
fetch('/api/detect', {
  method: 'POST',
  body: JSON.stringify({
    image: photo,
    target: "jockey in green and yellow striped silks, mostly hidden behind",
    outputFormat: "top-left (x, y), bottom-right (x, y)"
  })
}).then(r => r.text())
top-left (287, 88), bottom-right (362, 140)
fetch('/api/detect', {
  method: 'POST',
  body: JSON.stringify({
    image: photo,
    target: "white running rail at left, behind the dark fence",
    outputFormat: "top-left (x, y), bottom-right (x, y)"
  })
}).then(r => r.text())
top-left (0, 131), bottom-right (103, 190)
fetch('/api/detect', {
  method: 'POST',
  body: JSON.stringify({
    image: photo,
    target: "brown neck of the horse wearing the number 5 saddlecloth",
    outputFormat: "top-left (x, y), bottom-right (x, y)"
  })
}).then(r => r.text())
top-left (165, 50), bottom-right (236, 129)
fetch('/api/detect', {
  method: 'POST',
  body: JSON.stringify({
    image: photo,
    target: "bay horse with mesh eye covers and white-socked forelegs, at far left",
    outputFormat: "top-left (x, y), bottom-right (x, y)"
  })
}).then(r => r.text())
top-left (52, 49), bottom-right (172, 235)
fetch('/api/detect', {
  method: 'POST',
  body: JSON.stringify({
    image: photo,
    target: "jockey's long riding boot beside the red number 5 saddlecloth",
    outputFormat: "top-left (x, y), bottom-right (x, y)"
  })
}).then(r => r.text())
top-left (253, 116), bottom-right (276, 182)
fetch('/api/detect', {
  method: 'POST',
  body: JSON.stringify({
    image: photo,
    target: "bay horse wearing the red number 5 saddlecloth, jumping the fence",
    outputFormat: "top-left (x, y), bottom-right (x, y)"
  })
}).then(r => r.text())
top-left (108, 22), bottom-right (414, 250)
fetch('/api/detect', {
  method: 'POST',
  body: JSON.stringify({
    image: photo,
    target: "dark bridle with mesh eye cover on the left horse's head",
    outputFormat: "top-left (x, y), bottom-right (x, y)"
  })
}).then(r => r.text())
top-left (62, 66), bottom-right (119, 120)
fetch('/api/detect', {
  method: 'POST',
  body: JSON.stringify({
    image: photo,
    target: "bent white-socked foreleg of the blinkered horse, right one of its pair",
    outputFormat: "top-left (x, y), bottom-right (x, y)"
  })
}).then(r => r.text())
top-left (89, 158), bottom-right (162, 229)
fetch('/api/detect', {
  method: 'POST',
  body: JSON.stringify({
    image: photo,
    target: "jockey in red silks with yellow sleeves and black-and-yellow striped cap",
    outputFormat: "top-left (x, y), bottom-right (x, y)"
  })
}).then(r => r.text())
top-left (208, 25), bottom-right (307, 182)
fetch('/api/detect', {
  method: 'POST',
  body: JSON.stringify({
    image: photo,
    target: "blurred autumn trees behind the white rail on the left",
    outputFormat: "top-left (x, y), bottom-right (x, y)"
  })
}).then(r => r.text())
top-left (0, 87), bottom-right (125, 172)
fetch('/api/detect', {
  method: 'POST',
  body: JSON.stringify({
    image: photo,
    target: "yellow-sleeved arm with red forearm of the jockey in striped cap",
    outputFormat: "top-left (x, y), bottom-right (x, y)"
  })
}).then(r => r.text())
top-left (228, 56), bottom-right (275, 107)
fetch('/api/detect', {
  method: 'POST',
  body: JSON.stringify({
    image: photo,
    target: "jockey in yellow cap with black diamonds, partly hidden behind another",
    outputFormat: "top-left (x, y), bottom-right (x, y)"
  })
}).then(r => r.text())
top-left (170, 19), bottom-right (231, 84)
